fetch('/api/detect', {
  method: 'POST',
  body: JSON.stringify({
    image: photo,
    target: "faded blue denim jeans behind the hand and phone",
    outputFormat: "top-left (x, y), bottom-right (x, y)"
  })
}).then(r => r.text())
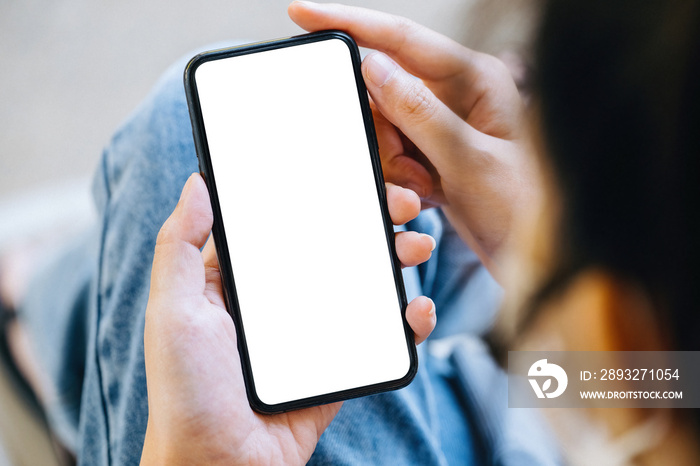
top-left (20, 44), bottom-right (556, 465)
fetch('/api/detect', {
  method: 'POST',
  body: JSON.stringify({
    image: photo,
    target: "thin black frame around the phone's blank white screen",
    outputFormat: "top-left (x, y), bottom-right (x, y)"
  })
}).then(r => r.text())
top-left (184, 30), bottom-right (418, 414)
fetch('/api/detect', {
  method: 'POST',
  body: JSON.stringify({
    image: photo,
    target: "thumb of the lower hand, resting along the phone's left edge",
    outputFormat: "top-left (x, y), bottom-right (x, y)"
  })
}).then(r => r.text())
top-left (151, 173), bottom-right (213, 297)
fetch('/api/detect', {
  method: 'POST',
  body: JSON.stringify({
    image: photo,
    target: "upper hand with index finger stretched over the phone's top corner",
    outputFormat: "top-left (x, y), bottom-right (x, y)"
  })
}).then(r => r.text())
top-left (289, 1), bottom-right (536, 277)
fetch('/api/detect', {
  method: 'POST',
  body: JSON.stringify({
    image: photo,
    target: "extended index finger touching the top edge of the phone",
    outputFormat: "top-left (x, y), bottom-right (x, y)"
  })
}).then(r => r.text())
top-left (287, 1), bottom-right (479, 80)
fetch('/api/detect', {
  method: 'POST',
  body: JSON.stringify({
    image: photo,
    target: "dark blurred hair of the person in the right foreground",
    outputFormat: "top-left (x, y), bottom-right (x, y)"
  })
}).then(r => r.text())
top-left (534, 0), bottom-right (700, 350)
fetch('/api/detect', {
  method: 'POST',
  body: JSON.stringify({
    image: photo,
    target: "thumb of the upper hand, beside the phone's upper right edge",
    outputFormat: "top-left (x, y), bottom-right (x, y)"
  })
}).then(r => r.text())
top-left (362, 52), bottom-right (478, 174)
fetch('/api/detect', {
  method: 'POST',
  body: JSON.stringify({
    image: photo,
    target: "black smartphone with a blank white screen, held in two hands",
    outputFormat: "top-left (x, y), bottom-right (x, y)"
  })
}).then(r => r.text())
top-left (185, 31), bottom-right (417, 413)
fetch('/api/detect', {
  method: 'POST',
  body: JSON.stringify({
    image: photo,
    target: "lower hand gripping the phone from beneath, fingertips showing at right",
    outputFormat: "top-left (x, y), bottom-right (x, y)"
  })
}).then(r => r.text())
top-left (141, 174), bottom-right (435, 465)
